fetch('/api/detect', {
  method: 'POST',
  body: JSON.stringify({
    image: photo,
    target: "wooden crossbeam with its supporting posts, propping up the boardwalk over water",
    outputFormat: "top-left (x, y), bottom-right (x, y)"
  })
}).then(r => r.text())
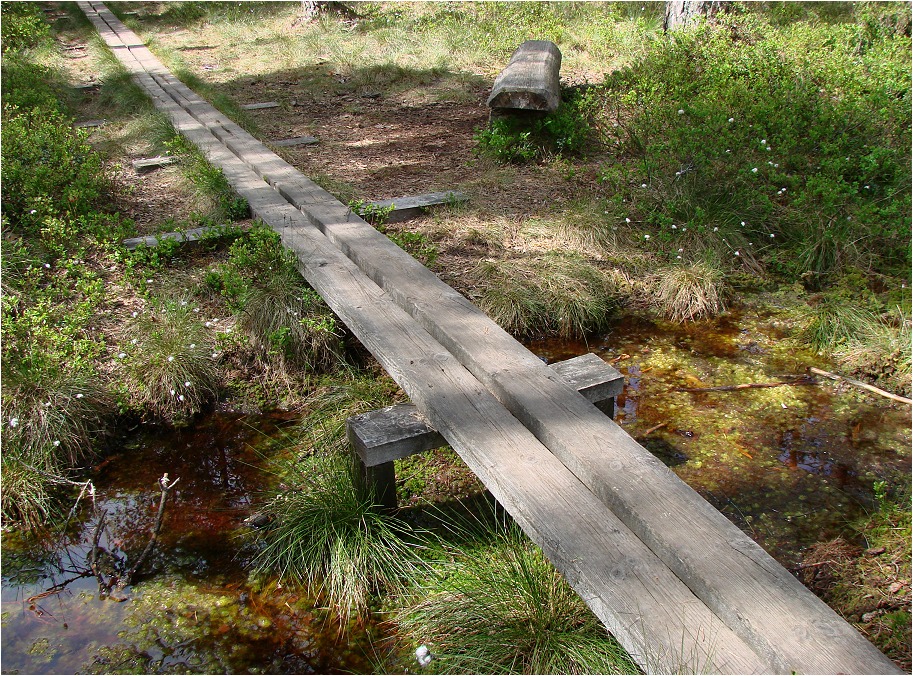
top-left (346, 353), bottom-right (624, 510)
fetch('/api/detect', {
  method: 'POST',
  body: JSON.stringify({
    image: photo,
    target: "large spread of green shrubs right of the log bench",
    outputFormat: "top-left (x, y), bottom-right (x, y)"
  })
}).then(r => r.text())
top-left (592, 10), bottom-right (911, 288)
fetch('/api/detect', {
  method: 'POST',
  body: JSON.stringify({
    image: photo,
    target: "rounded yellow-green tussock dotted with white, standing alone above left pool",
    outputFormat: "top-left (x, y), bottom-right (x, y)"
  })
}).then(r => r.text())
top-left (118, 300), bottom-right (219, 422)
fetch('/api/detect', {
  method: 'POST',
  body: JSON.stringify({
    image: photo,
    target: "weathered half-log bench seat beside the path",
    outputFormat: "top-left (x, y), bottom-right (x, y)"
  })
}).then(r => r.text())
top-left (488, 40), bottom-right (561, 112)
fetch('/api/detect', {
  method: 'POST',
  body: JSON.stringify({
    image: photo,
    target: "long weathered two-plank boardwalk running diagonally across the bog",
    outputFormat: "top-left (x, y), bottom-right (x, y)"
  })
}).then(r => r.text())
top-left (79, 1), bottom-right (899, 673)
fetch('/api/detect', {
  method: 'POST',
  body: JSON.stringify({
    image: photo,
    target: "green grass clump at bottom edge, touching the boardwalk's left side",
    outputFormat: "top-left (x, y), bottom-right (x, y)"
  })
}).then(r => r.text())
top-left (394, 526), bottom-right (638, 674)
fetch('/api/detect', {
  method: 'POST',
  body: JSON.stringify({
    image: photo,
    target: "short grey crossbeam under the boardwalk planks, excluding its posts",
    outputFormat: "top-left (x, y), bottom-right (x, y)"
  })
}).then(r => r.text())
top-left (347, 353), bottom-right (624, 467)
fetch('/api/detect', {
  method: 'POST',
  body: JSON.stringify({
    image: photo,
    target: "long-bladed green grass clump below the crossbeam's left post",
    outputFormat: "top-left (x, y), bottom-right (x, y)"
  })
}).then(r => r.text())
top-left (255, 440), bottom-right (421, 623)
